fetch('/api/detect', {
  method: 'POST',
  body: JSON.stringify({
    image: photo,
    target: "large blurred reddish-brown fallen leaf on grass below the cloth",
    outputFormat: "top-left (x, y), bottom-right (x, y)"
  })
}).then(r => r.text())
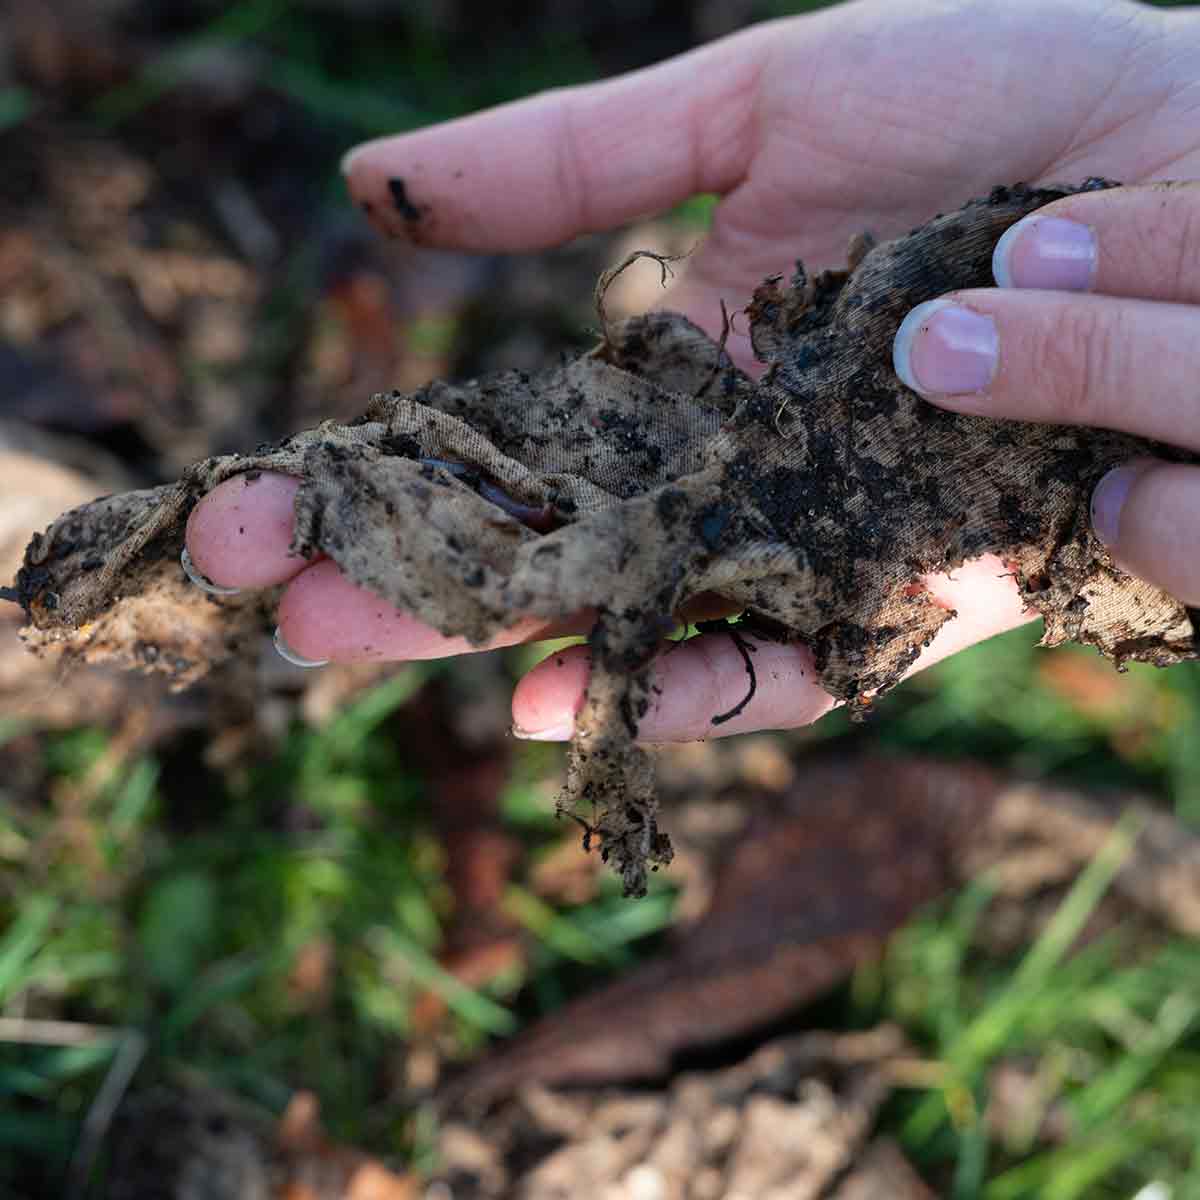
top-left (445, 763), bottom-right (984, 1108)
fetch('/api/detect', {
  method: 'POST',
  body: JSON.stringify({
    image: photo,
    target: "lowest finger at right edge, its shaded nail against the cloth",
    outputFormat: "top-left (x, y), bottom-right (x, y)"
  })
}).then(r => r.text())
top-left (1092, 460), bottom-right (1200, 606)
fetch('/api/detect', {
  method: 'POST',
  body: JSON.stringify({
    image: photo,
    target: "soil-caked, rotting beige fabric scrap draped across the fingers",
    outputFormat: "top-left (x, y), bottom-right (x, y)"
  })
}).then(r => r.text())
top-left (11, 180), bottom-right (1198, 894)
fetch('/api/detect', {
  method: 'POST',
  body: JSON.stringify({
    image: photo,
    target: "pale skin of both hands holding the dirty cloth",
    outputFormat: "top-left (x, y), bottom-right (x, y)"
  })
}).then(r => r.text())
top-left (187, 0), bottom-right (1200, 742)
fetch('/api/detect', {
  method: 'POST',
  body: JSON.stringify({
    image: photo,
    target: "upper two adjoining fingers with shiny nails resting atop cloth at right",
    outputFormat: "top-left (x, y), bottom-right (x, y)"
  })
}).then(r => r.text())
top-left (894, 175), bottom-right (1200, 449)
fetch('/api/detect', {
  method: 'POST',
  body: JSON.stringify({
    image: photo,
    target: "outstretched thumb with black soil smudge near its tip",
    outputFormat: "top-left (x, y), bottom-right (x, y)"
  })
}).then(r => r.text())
top-left (342, 26), bottom-right (772, 251)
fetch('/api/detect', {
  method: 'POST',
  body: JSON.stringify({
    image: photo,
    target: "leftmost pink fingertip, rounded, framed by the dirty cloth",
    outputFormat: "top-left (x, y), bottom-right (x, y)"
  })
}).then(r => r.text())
top-left (187, 472), bottom-right (305, 588)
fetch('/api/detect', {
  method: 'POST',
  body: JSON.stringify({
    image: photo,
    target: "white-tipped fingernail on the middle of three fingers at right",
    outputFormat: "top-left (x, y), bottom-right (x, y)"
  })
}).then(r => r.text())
top-left (892, 300), bottom-right (1000, 396)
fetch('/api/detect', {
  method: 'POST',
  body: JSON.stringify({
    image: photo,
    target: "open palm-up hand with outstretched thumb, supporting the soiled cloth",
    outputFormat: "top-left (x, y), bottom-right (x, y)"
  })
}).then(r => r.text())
top-left (188, 0), bottom-right (1200, 740)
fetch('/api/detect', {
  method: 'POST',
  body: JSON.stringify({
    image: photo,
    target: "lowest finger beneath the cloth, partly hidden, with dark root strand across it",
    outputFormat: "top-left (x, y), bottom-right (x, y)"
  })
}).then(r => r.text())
top-left (512, 556), bottom-right (1034, 742)
